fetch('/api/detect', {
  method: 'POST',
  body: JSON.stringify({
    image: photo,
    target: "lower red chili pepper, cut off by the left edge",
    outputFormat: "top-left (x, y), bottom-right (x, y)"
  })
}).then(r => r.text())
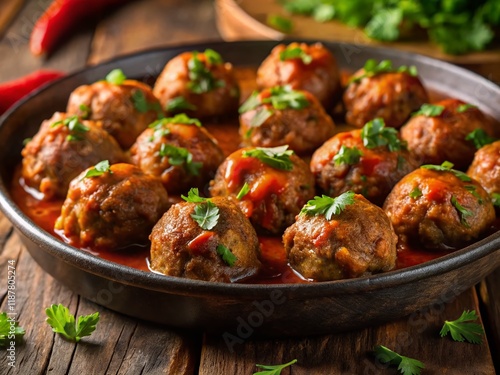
top-left (0, 70), bottom-right (64, 115)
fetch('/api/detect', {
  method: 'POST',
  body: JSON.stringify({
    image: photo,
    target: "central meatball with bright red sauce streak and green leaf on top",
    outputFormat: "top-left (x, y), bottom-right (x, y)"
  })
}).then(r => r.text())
top-left (210, 146), bottom-right (314, 234)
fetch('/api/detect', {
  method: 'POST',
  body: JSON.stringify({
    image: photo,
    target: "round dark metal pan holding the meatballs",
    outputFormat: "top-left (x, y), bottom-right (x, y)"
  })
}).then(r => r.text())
top-left (0, 41), bottom-right (500, 342)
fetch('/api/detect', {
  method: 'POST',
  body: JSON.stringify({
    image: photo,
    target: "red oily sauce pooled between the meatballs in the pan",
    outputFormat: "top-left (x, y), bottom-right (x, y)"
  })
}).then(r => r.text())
top-left (11, 67), bottom-right (500, 284)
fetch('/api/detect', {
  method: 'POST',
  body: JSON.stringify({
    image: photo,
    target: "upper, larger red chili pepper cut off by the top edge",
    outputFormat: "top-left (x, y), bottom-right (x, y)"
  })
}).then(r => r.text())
top-left (30, 0), bottom-right (126, 56)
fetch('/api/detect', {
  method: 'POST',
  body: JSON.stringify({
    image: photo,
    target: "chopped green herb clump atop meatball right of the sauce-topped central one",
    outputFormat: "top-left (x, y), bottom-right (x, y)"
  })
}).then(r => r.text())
top-left (361, 118), bottom-right (406, 152)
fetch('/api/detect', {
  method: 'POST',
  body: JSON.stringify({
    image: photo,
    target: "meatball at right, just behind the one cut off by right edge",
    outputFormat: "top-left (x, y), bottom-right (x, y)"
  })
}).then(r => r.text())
top-left (401, 99), bottom-right (494, 170)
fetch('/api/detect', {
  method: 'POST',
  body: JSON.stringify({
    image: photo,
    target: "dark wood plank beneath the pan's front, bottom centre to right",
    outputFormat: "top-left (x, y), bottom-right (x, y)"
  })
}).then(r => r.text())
top-left (199, 289), bottom-right (495, 375)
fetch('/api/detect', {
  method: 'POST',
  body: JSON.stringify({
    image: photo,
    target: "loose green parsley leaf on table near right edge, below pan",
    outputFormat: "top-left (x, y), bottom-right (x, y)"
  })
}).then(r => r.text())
top-left (439, 310), bottom-right (484, 344)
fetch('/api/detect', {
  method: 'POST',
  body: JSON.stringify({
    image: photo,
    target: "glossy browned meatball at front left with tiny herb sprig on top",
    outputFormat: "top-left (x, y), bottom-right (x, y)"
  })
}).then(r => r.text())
top-left (55, 162), bottom-right (169, 250)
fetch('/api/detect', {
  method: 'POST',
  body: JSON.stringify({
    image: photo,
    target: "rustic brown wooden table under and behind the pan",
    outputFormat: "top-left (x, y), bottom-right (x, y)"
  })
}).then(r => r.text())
top-left (0, 0), bottom-right (500, 375)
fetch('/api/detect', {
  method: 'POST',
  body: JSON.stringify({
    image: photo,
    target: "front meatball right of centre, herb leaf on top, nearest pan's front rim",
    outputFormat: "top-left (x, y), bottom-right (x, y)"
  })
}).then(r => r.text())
top-left (283, 192), bottom-right (397, 281)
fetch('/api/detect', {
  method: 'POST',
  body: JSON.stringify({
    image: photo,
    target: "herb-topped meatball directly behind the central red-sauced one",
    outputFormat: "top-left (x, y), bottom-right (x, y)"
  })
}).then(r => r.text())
top-left (240, 86), bottom-right (335, 154)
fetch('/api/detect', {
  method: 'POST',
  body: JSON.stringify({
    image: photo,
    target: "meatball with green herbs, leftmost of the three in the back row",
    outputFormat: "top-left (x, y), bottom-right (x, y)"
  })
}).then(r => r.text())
top-left (153, 49), bottom-right (240, 118)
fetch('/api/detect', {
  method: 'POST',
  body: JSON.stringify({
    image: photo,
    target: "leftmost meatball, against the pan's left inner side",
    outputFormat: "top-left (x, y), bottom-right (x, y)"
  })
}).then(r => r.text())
top-left (22, 112), bottom-right (127, 200)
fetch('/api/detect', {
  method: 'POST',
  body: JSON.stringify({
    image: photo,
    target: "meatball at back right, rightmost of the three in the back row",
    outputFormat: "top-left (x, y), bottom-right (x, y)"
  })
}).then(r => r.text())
top-left (344, 60), bottom-right (429, 128)
